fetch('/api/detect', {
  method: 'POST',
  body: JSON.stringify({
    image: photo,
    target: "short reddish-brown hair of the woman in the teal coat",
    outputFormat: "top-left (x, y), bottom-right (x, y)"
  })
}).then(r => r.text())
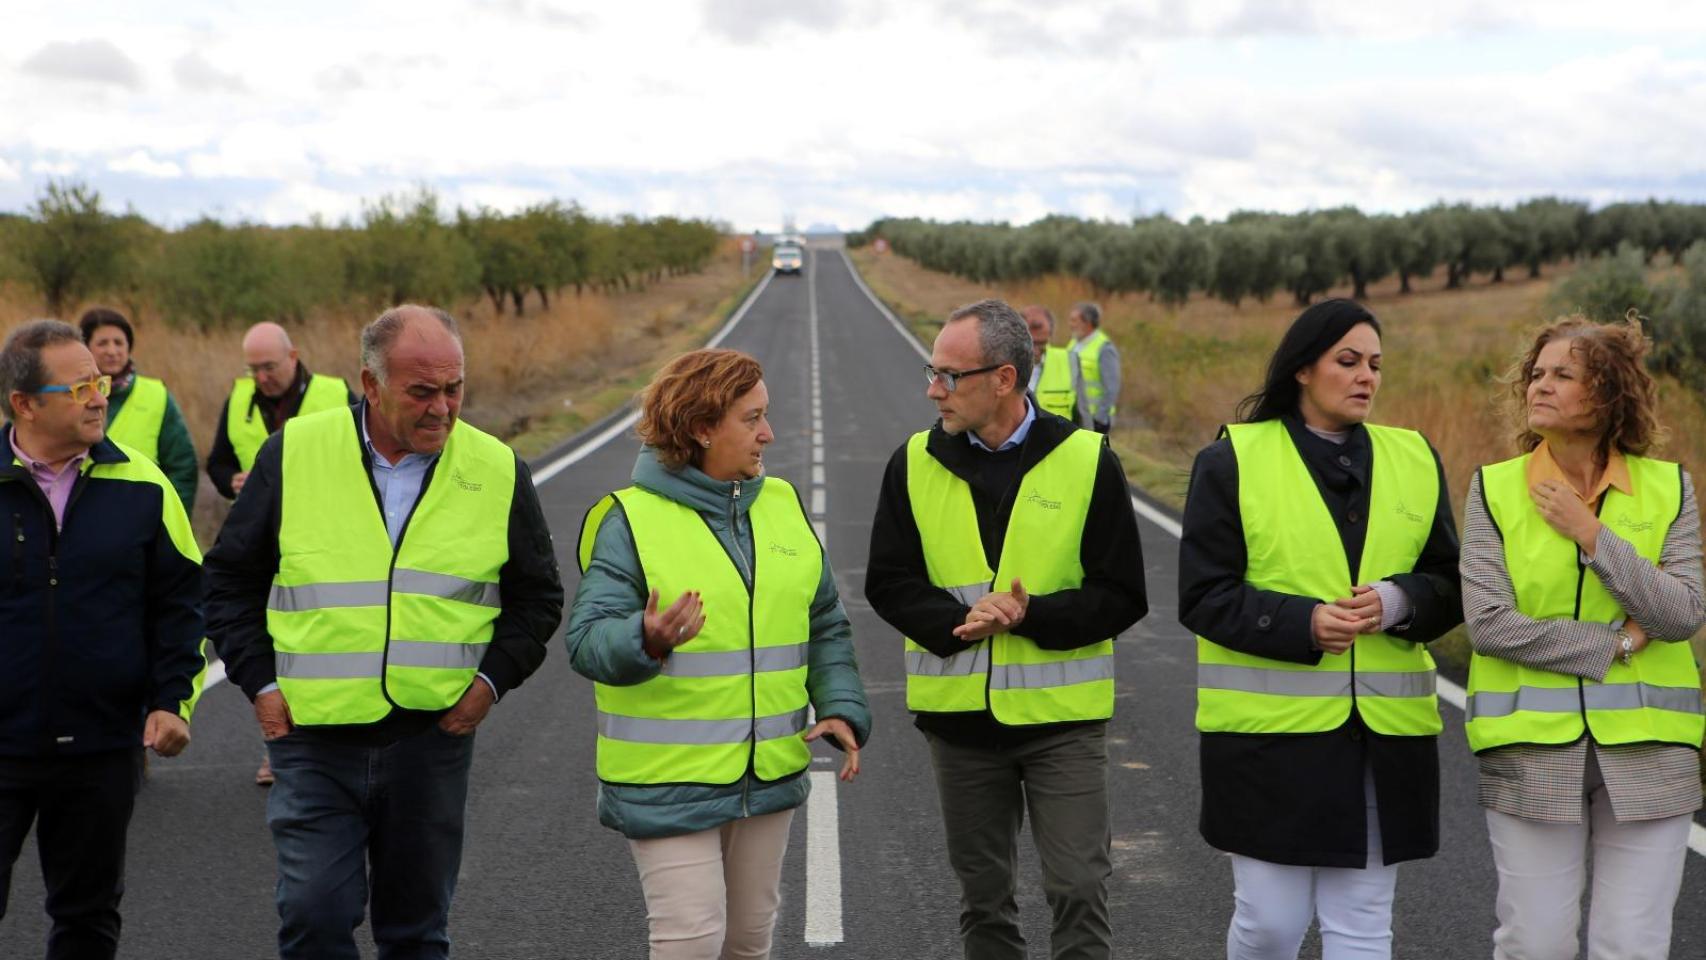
top-left (635, 350), bottom-right (764, 471)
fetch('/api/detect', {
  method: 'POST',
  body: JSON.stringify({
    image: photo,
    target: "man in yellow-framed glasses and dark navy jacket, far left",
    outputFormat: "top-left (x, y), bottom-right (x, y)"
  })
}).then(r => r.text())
top-left (0, 321), bottom-right (201, 958)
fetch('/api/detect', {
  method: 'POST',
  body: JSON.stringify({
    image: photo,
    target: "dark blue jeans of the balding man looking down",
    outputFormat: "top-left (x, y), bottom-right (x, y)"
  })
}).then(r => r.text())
top-left (266, 725), bottom-right (474, 960)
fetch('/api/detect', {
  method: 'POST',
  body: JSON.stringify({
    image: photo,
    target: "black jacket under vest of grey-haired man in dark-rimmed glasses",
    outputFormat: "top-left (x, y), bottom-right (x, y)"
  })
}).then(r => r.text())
top-left (865, 409), bottom-right (1150, 747)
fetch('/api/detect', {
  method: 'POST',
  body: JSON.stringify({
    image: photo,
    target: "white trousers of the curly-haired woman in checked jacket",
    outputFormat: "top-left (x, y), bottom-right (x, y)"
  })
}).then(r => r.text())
top-left (1488, 764), bottom-right (1692, 960)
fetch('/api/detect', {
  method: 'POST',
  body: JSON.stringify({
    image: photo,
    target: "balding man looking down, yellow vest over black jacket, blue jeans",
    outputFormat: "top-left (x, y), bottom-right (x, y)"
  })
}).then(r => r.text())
top-left (208, 305), bottom-right (563, 960)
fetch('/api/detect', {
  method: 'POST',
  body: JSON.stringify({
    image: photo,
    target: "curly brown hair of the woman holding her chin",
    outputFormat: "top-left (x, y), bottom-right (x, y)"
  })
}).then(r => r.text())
top-left (1505, 310), bottom-right (1665, 455)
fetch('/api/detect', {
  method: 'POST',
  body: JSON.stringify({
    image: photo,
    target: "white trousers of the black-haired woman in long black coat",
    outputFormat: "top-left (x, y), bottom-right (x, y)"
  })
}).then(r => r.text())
top-left (1227, 778), bottom-right (1397, 960)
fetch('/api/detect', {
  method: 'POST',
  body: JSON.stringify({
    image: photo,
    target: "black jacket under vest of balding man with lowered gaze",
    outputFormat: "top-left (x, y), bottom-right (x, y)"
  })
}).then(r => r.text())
top-left (206, 404), bottom-right (563, 742)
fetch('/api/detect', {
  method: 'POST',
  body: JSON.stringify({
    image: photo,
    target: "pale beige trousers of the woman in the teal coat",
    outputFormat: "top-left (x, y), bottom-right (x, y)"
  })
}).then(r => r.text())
top-left (628, 810), bottom-right (793, 960)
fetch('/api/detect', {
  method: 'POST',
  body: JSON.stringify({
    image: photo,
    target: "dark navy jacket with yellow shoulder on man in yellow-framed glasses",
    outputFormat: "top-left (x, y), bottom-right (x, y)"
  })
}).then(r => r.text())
top-left (0, 425), bottom-right (203, 757)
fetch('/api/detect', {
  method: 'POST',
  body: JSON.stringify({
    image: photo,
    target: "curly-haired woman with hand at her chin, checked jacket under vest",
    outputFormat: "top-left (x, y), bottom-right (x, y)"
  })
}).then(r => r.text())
top-left (1462, 317), bottom-right (1706, 960)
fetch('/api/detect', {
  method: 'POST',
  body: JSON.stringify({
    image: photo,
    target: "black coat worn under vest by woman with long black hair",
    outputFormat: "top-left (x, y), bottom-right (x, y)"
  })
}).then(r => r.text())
top-left (1179, 418), bottom-right (1464, 866)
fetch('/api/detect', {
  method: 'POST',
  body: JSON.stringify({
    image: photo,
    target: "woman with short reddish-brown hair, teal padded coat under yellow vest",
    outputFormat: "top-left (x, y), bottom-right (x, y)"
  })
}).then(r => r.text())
top-left (568, 350), bottom-right (870, 960)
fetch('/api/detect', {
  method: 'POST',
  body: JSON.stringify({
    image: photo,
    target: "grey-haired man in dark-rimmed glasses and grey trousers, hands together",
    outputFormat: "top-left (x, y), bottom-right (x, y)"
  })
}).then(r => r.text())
top-left (865, 300), bottom-right (1148, 960)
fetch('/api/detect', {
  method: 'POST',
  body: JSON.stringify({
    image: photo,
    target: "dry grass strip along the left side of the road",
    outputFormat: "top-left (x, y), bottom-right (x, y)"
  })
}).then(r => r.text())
top-left (0, 240), bottom-right (759, 546)
